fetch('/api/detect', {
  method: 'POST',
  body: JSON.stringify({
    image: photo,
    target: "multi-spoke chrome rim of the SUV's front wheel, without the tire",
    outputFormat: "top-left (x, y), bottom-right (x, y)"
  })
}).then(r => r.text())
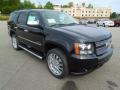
top-left (48, 53), bottom-right (63, 75)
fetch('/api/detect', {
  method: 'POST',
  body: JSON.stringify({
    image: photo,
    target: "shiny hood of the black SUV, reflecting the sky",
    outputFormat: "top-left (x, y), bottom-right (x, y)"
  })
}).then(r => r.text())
top-left (53, 25), bottom-right (111, 41)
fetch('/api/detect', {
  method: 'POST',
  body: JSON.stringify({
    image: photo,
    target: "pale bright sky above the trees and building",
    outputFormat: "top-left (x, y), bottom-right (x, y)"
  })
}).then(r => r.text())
top-left (22, 0), bottom-right (120, 13)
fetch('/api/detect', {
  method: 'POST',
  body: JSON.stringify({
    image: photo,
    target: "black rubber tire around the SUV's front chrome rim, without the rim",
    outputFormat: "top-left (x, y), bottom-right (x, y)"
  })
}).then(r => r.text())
top-left (46, 48), bottom-right (69, 79)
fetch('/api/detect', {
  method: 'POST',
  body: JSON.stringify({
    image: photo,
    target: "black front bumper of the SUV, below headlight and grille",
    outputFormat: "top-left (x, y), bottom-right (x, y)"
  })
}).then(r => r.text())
top-left (69, 48), bottom-right (113, 75)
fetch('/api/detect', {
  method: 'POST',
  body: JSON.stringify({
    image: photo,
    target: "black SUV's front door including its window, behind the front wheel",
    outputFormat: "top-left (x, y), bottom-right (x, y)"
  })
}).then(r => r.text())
top-left (25, 12), bottom-right (44, 51)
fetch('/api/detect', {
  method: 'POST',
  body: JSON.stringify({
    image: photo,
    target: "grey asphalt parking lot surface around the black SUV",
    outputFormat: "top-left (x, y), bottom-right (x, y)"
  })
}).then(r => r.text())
top-left (0, 22), bottom-right (120, 90)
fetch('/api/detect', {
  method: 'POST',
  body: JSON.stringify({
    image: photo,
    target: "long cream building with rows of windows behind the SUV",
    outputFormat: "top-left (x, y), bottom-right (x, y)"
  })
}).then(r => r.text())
top-left (54, 5), bottom-right (111, 18)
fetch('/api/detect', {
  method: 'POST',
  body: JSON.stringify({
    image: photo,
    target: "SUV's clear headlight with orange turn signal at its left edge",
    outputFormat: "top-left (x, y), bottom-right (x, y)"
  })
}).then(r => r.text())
top-left (74, 43), bottom-right (94, 55)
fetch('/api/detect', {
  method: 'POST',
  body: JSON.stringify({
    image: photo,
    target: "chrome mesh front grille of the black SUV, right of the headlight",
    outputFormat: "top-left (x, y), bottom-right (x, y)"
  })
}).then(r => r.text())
top-left (95, 38), bottom-right (111, 55)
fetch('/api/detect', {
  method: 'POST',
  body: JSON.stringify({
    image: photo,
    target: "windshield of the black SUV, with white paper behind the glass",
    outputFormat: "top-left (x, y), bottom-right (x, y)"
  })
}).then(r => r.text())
top-left (42, 11), bottom-right (78, 27)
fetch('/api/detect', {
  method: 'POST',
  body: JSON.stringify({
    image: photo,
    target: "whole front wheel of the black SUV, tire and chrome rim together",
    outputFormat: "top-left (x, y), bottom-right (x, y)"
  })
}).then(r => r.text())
top-left (47, 48), bottom-right (68, 79)
